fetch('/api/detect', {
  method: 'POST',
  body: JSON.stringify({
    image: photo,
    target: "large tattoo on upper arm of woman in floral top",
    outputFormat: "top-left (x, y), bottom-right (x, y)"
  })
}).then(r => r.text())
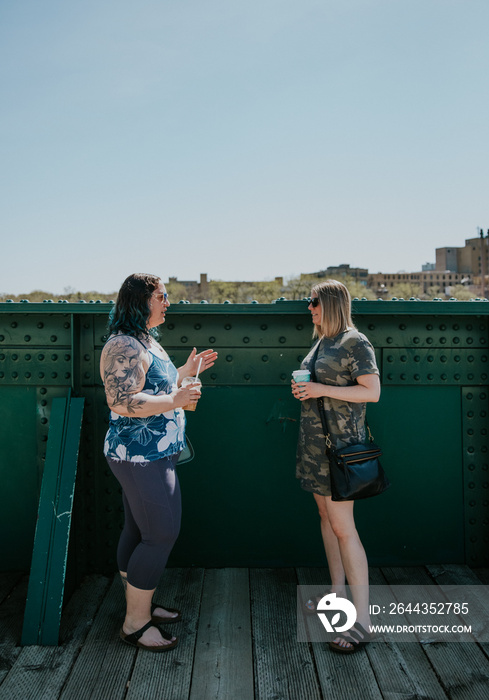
top-left (103, 335), bottom-right (146, 413)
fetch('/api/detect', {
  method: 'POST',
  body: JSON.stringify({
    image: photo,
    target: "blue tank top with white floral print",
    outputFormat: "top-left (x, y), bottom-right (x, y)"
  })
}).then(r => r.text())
top-left (104, 348), bottom-right (186, 462)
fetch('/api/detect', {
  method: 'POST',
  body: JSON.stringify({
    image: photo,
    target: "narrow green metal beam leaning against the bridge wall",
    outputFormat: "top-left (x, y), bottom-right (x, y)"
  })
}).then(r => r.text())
top-left (22, 392), bottom-right (85, 645)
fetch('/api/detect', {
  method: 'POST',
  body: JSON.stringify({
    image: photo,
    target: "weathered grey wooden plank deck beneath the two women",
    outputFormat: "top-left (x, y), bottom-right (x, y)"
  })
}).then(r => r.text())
top-left (0, 565), bottom-right (489, 700)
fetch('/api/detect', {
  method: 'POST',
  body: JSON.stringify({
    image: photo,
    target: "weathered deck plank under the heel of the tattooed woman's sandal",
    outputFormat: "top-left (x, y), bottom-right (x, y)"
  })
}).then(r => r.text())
top-left (60, 574), bottom-right (136, 700)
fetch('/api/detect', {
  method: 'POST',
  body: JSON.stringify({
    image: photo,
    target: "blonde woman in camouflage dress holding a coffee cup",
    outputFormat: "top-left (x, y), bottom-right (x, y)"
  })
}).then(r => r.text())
top-left (292, 280), bottom-right (380, 653)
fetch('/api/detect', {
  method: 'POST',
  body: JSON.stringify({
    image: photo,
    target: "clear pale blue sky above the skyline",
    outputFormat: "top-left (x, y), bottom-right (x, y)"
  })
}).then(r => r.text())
top-left (0, 0), bottom-right (489, 294)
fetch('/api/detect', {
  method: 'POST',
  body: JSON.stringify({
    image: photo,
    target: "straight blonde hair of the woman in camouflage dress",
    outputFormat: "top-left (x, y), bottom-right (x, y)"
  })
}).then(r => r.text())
top-left (311, 280), bottom-right (355, 338)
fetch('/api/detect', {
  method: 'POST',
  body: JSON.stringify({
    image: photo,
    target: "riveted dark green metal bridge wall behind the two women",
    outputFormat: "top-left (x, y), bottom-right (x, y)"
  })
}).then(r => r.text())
top-left (0, 301), bottom-right (489, 575)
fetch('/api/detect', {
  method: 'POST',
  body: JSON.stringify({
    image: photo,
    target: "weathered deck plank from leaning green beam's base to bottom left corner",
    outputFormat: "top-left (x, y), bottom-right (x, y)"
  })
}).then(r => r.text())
top-left (0, 576), bottom-right (109, 700)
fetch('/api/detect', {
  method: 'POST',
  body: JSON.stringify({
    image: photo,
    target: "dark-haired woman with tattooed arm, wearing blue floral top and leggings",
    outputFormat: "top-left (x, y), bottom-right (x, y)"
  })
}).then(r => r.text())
top-left (100, 274), bottom-right (217, 652)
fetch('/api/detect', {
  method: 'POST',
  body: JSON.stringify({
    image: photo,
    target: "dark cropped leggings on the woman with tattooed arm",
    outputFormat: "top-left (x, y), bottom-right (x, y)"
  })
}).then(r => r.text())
top-left (107, 455), bottom-right (182, 591)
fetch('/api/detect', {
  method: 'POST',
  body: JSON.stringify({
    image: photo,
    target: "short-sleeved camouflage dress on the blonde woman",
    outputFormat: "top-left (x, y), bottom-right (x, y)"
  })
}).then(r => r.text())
top-left (296, 328), bottom-right (379, 496)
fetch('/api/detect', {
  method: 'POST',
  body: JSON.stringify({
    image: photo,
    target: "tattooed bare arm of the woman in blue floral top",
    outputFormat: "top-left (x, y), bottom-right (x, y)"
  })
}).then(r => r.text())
top-left (100, 335), bottom-right (200, 418)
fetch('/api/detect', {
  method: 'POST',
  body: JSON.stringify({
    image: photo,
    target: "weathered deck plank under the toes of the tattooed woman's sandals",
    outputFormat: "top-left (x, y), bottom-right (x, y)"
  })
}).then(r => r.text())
top-left (126, 568), bottom-right (204, 700)
